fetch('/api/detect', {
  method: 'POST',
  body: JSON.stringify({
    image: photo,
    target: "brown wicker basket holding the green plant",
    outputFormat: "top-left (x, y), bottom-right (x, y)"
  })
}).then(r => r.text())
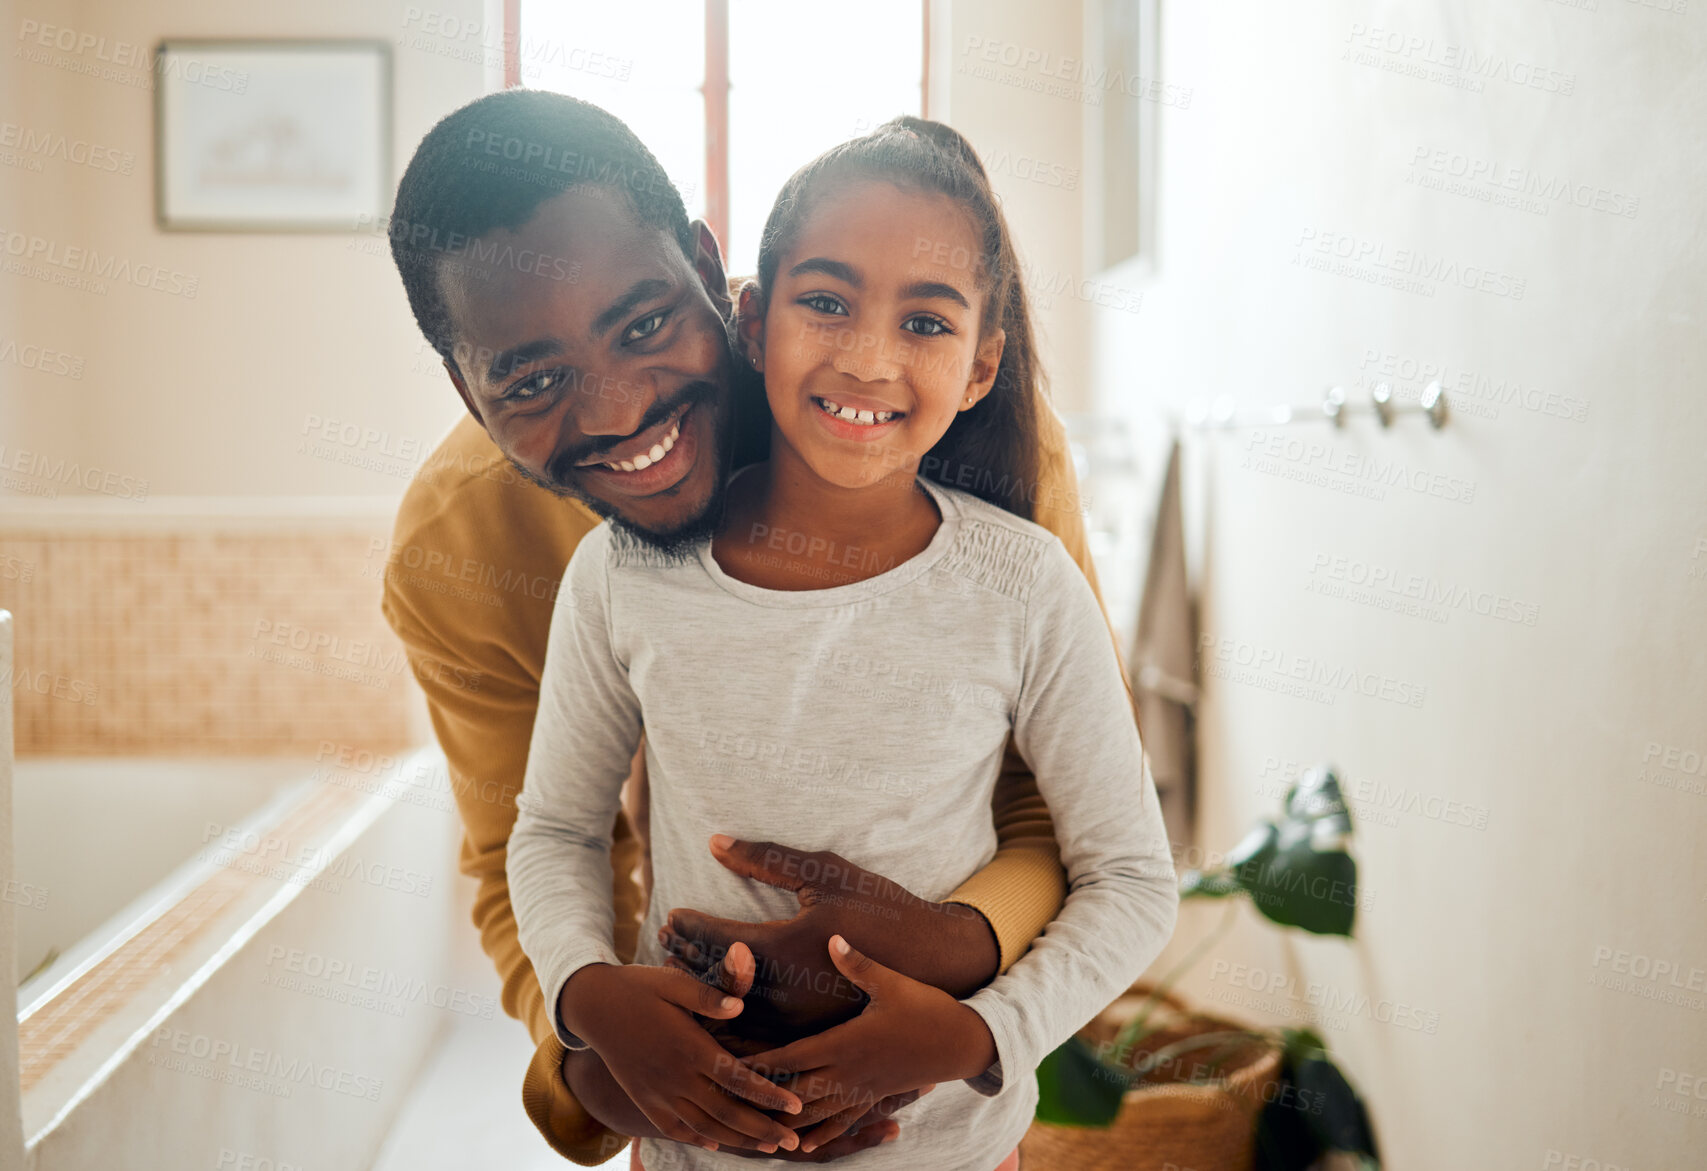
top-left (1019, 985), bottom-right (1280, 1171)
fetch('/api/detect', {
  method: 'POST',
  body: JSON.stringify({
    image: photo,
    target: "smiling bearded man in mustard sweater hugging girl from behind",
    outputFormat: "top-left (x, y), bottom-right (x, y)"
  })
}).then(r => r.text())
top-left (384, 90), bottom-right (1133, 1164)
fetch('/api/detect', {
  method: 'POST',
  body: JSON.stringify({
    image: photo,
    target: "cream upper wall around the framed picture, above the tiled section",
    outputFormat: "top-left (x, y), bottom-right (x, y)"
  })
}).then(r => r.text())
top-left (0, 0), bottom-right (502, 495)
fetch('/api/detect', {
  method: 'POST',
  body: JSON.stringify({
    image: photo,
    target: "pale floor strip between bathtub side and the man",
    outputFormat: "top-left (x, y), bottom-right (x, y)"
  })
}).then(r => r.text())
top-left (372, 1016), bottom-right (628, 1171)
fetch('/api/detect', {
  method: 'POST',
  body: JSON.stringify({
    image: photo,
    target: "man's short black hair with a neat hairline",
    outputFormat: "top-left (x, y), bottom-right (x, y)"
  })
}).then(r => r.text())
top-left (387, 89), bottom-right (693, 362)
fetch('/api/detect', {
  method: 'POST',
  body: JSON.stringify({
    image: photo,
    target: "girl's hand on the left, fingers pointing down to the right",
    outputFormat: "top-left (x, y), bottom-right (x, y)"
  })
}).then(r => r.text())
top-left (558, 949), bottom-right (801, 1151)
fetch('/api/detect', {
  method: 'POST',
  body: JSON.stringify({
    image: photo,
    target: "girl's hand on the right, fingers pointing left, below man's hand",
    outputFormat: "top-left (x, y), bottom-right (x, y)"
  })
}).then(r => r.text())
top-left (748, 935), bottom-right (995, 1152)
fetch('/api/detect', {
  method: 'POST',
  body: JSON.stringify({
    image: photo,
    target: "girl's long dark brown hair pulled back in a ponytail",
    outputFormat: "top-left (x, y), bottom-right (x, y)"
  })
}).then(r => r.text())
top-left (756, 116), bottom-right (1050, 521)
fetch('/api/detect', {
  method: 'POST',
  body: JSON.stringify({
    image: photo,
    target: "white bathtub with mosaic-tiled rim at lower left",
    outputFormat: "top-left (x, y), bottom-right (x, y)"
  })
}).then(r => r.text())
top-left (12, 749), bottom-right (464, 1171)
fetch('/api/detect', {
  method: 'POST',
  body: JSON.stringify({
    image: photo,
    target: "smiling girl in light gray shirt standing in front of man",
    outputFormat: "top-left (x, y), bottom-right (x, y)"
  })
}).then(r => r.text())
top-left (509, 118), bottom-right (1178, 1171)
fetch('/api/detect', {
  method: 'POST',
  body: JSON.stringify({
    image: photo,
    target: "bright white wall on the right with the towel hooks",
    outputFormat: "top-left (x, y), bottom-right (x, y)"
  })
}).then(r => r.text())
top-left (1096, 0), bottom-right (1707, 1171)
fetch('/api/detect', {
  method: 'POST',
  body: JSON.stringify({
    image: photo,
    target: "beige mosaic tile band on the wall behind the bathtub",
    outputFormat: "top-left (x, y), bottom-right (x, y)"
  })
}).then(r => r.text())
top-left (0, 521), bottom-right (422, 756)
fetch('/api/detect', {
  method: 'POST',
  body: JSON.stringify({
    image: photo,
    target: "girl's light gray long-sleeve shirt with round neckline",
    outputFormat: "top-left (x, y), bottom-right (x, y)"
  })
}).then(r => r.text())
top-left (507, 478), bottom-right (1178, 1171)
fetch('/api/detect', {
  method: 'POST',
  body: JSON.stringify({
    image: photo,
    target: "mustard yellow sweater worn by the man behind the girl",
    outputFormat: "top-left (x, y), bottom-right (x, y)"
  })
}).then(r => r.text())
top-left (384, 402), bottom-right (1126, 1164)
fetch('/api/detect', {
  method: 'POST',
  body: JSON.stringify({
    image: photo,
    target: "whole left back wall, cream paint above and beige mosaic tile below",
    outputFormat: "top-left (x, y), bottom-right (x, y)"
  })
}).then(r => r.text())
top-left (0, 0), bottom-right (502, 754)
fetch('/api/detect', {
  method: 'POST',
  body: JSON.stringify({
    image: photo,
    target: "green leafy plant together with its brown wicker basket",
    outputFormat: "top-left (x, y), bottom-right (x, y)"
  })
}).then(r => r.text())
top-left (1026, 766), bottom-right (1379, 1171)
